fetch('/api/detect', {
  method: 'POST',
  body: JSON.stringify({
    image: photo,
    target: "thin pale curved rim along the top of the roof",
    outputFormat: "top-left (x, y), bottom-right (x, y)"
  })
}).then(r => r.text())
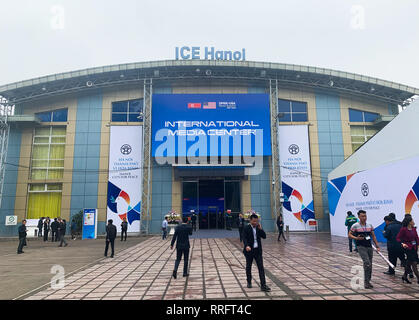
top-left (0, 60), bottom-right (419, 104)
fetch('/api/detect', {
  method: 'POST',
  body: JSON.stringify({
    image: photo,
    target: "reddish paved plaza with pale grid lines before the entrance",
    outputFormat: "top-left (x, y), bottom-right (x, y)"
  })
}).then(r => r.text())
top-left (17, 233), bottom-right (419, 300)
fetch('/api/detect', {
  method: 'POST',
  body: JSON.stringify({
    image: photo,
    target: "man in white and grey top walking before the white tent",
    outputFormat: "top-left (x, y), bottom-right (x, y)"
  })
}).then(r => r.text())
top-left (348, 210), bottom-right (380, 289)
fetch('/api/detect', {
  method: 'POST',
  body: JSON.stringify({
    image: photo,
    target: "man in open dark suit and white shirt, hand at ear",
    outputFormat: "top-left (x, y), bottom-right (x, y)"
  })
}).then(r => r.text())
top-left (243, 214), bottom-right (271, 292)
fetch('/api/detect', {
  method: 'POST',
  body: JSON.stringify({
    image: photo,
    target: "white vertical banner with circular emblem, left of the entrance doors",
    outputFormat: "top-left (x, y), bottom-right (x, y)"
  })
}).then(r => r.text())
top-left (107, 126), bottom-right (143, 233)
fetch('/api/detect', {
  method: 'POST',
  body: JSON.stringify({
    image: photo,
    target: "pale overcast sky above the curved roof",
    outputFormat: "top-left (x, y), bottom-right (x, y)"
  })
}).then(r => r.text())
top-left (0, 0), bottom-right (419, 88)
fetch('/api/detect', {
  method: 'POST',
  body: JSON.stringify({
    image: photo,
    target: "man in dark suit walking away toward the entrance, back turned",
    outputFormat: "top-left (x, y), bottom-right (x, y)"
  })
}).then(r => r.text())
top-left (170, 217), bottom-right (192, 279)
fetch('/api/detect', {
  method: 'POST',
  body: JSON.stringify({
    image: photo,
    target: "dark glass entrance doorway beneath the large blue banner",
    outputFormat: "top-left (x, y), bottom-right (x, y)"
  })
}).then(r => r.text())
top-left (182, 178), bottom-right (241, 229)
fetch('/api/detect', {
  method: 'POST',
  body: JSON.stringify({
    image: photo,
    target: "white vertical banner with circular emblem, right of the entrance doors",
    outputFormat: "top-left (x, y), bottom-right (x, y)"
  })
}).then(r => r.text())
top-left (278, 125), bottom-right (315, 231)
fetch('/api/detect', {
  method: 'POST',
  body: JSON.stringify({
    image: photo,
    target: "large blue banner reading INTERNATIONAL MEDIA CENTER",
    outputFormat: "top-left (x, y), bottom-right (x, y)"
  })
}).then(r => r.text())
top-left (152, 94), bottom-right (271, 157)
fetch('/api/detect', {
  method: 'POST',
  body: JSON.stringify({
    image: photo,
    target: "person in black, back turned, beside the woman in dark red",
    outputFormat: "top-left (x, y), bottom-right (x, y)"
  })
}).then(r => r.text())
top-left (383, 215), bottom-right (406, 275)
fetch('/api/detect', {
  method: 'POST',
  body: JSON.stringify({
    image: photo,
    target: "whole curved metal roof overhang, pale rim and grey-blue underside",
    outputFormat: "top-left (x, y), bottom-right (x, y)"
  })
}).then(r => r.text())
top-left (0, 60), bottom-right (419, 105)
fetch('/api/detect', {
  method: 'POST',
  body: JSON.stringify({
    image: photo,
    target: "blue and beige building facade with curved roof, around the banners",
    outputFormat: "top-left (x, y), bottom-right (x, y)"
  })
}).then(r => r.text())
top-left (0, 61), bottom-right (419, 236)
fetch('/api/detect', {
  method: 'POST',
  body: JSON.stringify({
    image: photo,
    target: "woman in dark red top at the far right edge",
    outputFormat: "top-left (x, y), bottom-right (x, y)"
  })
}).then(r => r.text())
top-left (396, 215), bottom-right (419, 283)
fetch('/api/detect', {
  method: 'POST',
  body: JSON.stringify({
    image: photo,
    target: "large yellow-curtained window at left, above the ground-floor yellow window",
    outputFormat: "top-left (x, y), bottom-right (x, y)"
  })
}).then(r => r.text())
top-left (31, 126), bottom-right (66, 180)
